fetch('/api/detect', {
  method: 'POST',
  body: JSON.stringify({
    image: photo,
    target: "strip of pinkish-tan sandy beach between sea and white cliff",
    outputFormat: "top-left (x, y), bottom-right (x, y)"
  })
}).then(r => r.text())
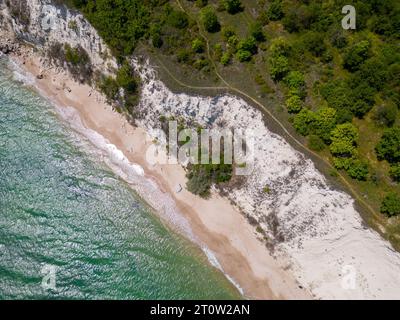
top-left (8, 48), bottom-right (311, 299)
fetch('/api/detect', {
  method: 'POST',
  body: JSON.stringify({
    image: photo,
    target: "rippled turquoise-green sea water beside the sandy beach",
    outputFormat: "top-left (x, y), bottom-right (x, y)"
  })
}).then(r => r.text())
top-left (0, 57), bottom-right (239, 299)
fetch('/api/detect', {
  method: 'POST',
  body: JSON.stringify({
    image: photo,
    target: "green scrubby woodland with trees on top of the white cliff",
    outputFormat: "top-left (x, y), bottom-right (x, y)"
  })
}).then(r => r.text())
top-left (57, 0), bottom-right (400, 241)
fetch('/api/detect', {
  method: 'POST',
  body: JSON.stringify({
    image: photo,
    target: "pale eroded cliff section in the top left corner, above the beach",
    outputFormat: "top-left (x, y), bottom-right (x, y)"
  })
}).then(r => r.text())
top-left (0, 0), bottom-right (117, 73)
